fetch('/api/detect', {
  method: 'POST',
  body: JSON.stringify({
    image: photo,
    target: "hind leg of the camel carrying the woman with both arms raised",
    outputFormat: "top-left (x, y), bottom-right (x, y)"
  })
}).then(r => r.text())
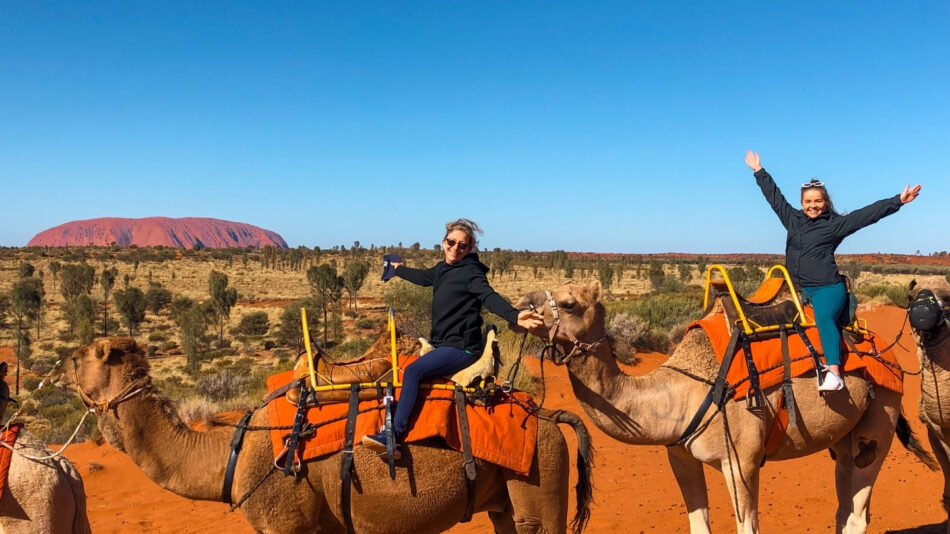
top-left (833, 389), bottom-right (901, 534)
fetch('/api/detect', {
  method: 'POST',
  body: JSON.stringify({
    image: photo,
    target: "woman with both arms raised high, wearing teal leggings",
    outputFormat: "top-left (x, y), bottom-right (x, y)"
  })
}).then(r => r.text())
top-left (745, 150), bottom-right (920, 391)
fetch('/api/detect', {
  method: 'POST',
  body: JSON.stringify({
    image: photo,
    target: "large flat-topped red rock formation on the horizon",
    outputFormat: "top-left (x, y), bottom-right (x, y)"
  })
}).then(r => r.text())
top-left (26, 217), bottom-right (287, 249)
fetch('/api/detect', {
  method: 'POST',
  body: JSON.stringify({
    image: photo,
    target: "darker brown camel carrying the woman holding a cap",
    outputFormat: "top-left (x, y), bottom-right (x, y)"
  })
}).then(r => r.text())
top-left (57, 338), bottom-right (590, 533)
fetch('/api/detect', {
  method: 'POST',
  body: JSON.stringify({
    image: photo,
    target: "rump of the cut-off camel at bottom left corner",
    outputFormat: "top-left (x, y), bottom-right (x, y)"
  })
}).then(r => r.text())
top-left (0, 430), bottom-right (91, 534)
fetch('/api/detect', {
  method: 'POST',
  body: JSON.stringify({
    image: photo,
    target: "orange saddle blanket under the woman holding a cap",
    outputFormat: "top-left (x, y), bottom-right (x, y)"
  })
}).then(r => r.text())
top-left (267, 356), bottom-right (538, 474)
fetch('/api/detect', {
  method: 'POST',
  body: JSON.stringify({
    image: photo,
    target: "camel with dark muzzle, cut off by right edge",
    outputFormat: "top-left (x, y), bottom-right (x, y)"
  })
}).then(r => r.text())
top-left (908, 276), bottom-right (950, 534)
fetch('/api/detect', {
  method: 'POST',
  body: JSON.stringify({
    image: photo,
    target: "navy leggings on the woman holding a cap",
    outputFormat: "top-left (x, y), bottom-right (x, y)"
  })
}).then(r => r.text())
top-left (393, 347), bottom-right (478, 438)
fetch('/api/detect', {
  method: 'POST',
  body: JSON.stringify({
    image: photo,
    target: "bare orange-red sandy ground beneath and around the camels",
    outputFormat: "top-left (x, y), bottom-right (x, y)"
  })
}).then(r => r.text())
top-left (66, 307), bottom-right (946, 534)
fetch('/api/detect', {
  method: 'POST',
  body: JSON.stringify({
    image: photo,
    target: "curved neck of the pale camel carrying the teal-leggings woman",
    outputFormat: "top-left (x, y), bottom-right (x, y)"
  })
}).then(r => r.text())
top-left (568, 343), bottom-right (700, 445)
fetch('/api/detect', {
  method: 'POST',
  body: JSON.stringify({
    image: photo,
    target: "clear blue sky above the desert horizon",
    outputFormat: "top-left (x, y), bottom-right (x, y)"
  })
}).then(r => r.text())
top-left (0, 1), bottom-right (950, 254)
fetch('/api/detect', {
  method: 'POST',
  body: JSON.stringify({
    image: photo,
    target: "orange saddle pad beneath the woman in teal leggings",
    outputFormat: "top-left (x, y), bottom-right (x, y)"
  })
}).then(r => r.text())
top-left (686, 307), bottom-right (904, 400)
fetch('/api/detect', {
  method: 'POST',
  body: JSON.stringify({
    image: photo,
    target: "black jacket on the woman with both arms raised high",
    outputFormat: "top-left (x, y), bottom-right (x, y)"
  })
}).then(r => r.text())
top-left (755, 169), bottom-right (901, 287)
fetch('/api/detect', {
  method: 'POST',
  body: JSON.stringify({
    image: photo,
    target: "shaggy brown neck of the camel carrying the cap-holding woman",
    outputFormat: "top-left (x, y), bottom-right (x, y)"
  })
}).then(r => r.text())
top-left (106, 388), bottom-right (231, 501)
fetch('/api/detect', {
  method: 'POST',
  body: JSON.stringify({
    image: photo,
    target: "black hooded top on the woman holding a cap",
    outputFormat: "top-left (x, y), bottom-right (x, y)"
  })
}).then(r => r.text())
top-left (396, 253), bottom-right (518, 354)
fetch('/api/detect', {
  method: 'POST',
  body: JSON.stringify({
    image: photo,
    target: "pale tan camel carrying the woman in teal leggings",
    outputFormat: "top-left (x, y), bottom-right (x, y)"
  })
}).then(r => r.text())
top-left (516, 282), bottom-right (932, 533)
